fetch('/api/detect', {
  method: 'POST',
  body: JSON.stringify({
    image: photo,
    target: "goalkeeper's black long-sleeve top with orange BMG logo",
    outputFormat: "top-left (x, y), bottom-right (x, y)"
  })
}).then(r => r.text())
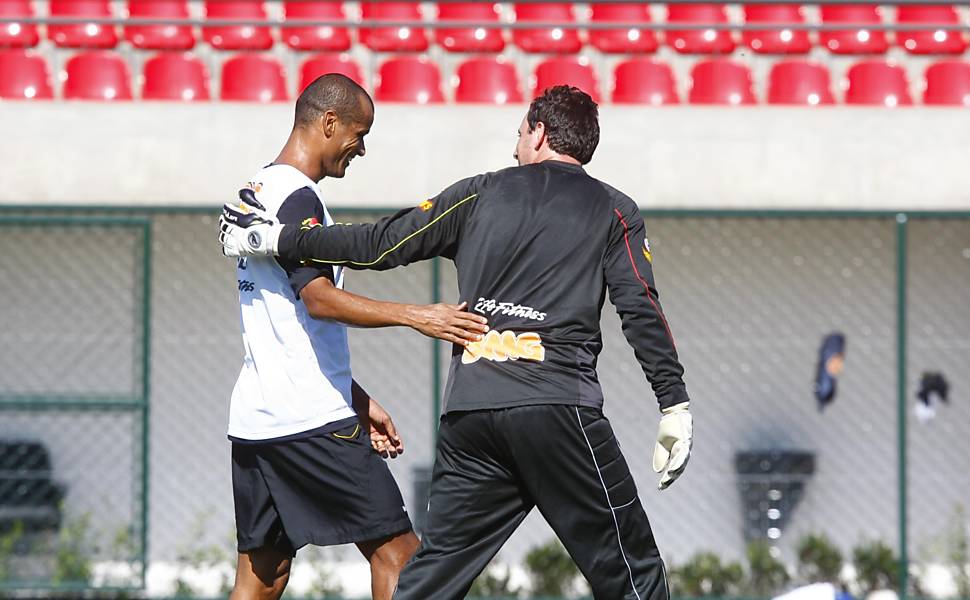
top-left (279, 161), bottom-right (688, 412)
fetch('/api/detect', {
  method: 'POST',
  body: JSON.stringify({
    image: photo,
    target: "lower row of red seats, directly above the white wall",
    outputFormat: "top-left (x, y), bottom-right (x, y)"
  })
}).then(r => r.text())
top-left (0, 51), bottom-right (970, 107)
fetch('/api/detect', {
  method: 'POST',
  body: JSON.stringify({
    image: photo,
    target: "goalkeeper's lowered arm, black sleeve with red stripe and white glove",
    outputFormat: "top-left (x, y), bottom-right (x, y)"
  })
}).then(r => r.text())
top-left (604, 201), bottom-right (693, 489)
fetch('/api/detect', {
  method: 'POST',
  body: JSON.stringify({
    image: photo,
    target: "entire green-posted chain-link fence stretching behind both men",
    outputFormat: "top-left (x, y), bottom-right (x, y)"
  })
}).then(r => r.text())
top-left (0, 209), bottom-right (970, 596)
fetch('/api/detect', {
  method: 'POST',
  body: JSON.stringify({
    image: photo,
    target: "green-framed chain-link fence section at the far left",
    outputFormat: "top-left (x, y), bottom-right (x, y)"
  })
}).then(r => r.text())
top-left (0, 215), bottom-right (151, 590)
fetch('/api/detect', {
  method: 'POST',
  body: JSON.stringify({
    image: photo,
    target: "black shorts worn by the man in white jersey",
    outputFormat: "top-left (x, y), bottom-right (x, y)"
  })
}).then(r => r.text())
top-left (232, 417), bottom-right (411, 556)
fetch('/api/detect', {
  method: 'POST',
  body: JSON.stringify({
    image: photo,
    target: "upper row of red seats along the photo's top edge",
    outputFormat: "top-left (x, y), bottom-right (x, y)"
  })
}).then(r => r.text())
top-left (0, 0), bottom-right (967, 54)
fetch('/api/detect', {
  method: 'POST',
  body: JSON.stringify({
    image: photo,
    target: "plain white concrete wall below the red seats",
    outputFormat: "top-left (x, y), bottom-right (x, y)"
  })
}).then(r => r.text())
top-left (0, 102), bottom-right (970, 209)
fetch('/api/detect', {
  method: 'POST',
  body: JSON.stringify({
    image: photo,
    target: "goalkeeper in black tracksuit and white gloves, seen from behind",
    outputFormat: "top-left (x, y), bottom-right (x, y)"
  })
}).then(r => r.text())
top-left (222, 87), bottom-right (691, 600)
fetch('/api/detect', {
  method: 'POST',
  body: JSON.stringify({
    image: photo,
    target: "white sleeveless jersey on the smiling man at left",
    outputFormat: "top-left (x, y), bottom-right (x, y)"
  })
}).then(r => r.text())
top-left (229, 165), bottom-right (356, 440)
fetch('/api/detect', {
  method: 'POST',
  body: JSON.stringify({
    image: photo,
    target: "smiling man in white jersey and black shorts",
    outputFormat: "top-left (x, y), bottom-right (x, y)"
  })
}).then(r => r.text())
top-left (229, 74), bottom-right (487, 600)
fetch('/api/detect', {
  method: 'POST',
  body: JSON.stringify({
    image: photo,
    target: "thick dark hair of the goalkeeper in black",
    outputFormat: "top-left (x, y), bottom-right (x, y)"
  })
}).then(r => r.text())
top-left (526, 85), bottom-right (600, 165)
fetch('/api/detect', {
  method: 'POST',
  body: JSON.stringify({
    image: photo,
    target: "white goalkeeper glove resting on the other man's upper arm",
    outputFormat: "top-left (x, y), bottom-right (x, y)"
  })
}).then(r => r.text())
top-left (219, 188), bottom-right (283, 257)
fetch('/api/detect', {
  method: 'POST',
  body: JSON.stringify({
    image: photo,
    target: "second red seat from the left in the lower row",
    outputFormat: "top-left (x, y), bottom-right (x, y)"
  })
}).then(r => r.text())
top-left (64, 51), bottom-right (131, 100)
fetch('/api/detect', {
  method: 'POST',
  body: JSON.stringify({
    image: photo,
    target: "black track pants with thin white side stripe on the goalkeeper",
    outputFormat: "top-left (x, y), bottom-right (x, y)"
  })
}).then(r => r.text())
top-left (394, 405), bottom-right (668, 600)
